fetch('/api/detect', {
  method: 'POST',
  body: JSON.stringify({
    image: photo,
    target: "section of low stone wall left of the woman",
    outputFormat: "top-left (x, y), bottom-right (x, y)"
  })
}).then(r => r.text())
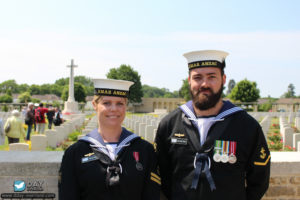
top-left (0, 151), bottom-right (63, 200)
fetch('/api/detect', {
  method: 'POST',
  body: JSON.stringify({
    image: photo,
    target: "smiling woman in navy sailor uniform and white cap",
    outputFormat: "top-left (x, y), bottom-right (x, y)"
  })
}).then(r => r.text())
top-left (59, 79), bottom-right (160, 200)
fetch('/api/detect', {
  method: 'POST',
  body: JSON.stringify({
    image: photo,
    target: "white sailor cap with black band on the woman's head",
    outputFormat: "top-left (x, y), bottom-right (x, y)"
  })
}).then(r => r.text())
top-left (92, 79), bottom-right (134, 98)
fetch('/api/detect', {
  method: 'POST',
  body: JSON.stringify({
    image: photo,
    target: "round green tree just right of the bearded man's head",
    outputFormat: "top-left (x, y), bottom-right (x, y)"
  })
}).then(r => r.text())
top-left (229, 79), bottom-right (259, 102)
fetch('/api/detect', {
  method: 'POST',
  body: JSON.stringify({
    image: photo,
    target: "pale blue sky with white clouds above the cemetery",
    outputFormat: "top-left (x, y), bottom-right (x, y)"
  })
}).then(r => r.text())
top-left (0, 0), bottom-right (300, 97)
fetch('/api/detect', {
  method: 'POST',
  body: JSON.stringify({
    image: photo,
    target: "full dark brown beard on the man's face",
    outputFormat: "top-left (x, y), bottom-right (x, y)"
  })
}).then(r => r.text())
top-left (190, 84), bottom-right (223, 110)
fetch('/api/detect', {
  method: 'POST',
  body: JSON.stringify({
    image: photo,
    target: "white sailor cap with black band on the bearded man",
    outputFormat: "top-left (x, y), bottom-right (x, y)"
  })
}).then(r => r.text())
top-left (183, 50), bottom-right (228, 70)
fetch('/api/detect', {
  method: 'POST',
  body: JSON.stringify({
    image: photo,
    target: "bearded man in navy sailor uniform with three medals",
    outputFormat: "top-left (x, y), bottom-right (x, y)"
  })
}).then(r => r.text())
top-left (154, 50), bottom-right (271, 200)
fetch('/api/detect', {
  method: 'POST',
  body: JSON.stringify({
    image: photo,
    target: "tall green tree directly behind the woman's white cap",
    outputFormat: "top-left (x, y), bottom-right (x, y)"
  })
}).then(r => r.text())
top-left (106, 65), bottom-right (143, 102)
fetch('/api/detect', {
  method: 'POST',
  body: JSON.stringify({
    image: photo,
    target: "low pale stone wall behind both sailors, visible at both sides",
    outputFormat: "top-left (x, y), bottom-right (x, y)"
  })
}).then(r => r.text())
top-left (0, 151), bottom-right (300, 200)
